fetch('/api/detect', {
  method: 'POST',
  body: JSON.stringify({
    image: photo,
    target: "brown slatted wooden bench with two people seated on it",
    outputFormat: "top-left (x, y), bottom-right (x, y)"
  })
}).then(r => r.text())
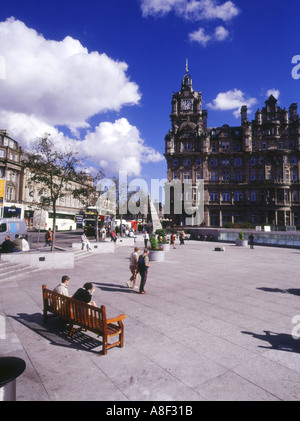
top-left (42, 285), bottom-right (126, 355)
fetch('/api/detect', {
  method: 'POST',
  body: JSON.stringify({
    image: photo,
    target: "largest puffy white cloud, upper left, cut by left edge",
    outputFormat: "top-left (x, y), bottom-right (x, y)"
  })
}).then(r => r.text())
top-left (0, 19), bottom-right (140, 129)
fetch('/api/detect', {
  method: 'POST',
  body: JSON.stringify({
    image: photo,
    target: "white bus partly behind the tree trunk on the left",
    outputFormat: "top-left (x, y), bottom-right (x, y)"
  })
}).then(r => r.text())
top-left (33, 209), bottom-right (77, 231)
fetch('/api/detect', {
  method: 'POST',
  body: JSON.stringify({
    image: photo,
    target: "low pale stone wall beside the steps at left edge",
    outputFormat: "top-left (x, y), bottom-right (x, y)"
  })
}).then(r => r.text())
top-left (1, 250), bottom-right (74, 269)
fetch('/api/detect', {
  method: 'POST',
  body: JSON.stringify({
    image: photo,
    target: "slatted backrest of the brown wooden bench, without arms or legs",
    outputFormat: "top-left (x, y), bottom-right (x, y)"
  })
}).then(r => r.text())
top-left (43, 285), bottom-right (106, 331)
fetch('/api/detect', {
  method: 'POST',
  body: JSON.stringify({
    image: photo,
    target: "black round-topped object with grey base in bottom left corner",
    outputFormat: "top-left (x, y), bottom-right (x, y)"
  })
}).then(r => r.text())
top-left (0, 357), bottom-right (26, 401)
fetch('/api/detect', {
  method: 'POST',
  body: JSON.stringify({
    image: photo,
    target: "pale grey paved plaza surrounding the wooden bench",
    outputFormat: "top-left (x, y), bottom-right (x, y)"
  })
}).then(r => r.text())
top-left (0, 236), bottom-right (300, 402)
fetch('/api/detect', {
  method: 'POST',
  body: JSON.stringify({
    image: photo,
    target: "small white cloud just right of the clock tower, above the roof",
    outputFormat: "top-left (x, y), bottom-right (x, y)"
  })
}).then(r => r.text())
top-left (207, 89), bottom-right (257, 117)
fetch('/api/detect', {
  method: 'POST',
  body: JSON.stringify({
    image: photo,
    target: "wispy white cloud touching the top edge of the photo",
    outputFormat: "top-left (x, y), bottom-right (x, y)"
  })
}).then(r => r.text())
top-left (141, 0), bottom-right (239, 22)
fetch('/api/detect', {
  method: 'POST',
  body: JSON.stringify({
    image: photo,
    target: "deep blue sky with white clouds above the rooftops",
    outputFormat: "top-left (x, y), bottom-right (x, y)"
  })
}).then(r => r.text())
top-left (0, 0), bottom-right (300, 185)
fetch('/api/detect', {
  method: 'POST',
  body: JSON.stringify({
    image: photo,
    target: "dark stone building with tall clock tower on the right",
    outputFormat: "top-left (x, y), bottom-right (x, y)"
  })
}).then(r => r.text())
top-left (165, 69), bottom-right (300, 227)
